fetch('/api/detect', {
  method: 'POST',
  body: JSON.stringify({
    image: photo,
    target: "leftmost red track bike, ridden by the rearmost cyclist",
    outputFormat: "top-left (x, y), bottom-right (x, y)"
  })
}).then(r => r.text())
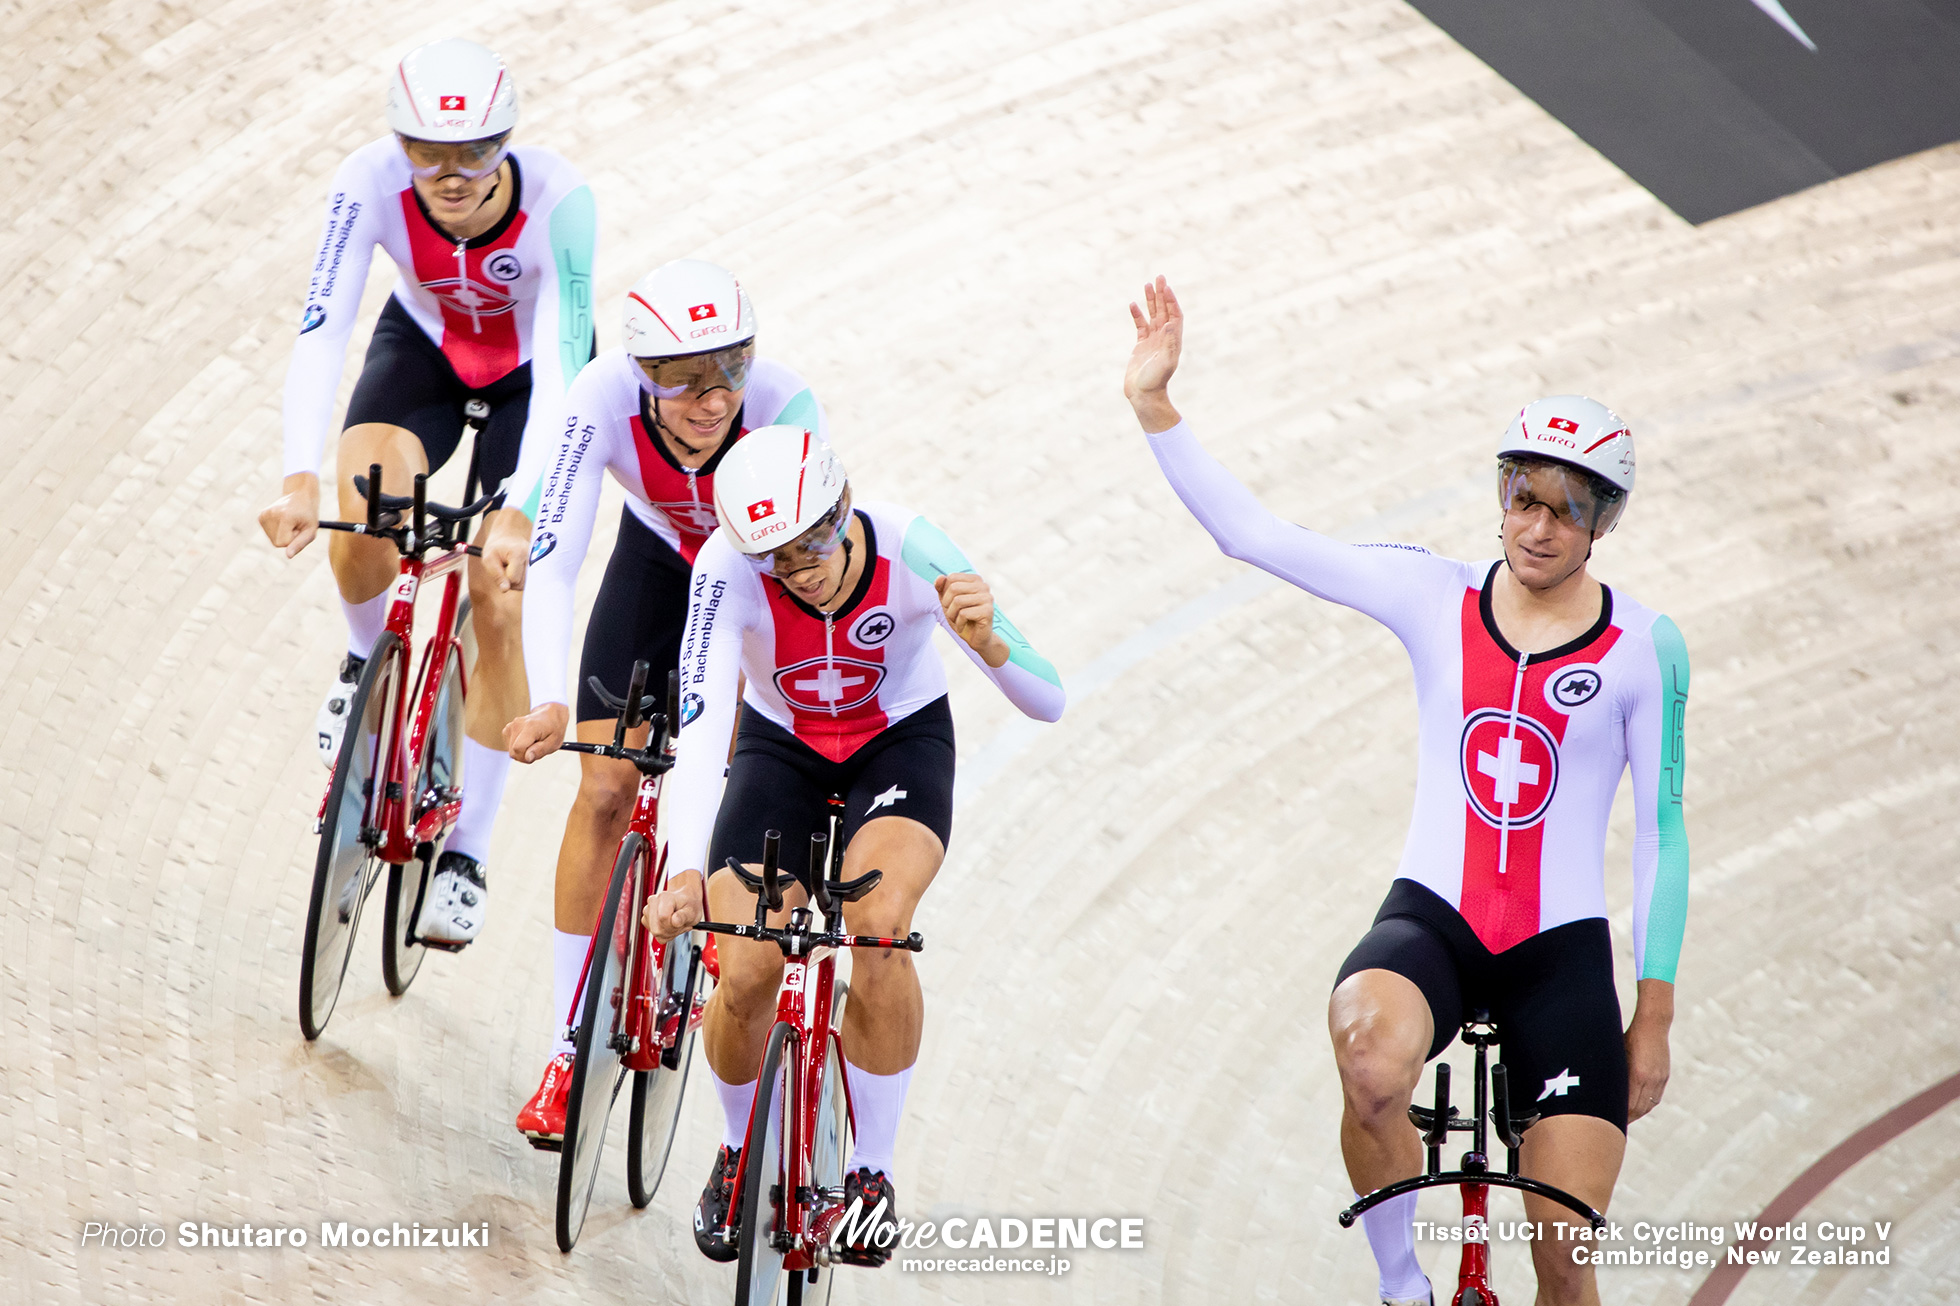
top-left (300, 465), bottom-right (496, 1039)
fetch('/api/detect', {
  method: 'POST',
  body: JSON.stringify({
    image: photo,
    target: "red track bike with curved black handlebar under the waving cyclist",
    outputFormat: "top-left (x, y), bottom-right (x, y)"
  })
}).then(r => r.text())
top-left (1341, 1012), bottom-right (1605, 1306)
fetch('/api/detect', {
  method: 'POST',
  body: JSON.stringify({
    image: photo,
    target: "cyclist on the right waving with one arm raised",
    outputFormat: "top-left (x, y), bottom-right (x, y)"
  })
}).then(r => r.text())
top-left (1123, 278), bottom-right (1688, 1304)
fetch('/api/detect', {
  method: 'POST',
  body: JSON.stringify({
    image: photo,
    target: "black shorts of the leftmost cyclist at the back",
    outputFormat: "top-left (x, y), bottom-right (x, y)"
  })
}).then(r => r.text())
top-left (341, 294), bottom-right (531, 494)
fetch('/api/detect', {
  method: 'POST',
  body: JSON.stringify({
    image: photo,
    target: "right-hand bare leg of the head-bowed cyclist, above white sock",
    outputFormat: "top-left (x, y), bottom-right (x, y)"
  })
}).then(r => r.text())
top-left (843, 816), bottom-right (947, 1075)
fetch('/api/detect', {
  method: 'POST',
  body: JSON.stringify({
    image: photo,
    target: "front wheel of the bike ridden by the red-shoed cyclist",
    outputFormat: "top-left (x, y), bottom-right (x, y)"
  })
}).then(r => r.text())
top-left (557, 833), bottom-right (653, 1251)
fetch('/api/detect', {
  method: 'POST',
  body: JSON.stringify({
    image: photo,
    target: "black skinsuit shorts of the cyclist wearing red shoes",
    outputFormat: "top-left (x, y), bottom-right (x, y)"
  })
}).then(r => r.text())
top-left (578, 508), bottom-right (690, 722)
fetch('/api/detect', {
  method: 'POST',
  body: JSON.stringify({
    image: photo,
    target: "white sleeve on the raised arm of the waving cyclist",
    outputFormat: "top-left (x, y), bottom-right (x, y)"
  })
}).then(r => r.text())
top-left (1149, 422), bottom-right (1456, 645)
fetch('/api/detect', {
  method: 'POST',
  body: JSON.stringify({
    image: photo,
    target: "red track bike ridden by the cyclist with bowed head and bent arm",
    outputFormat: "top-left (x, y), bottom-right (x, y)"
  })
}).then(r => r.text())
top-left (700, 796), bottom-right (925, 1306)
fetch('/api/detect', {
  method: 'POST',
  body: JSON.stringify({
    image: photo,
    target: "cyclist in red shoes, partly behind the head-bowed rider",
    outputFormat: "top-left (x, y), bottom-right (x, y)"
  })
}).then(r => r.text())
top-left (486, 259), bottom-right (823, 1143)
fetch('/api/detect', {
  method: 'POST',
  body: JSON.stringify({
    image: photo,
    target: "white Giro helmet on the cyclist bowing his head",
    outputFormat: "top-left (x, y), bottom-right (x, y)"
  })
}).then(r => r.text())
top-left (715, 426), bottom-right (845, 555)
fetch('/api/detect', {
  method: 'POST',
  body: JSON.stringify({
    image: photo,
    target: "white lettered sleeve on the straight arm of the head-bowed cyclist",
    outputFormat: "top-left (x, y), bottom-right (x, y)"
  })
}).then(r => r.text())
top-left (661, 535), bottom-right (760, 875)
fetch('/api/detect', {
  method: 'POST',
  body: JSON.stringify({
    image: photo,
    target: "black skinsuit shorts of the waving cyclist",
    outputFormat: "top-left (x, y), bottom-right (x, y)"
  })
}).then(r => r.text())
top-left (1335, 879), bottom-right (1627, 1133)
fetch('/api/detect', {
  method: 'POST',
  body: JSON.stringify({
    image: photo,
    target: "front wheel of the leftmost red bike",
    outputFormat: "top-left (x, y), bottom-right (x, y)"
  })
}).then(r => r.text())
top-left (300, 633), bottom-right (402, 1039)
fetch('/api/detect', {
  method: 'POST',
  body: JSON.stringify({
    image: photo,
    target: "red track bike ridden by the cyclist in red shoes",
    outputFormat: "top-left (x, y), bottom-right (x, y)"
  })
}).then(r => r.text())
top-left (533, 661), bottom-right (708, 1251)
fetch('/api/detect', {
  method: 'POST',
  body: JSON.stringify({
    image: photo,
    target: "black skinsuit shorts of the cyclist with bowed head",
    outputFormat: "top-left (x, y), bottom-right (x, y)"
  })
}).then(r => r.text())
top-left (708, 696), bottom-right (953, 888)
